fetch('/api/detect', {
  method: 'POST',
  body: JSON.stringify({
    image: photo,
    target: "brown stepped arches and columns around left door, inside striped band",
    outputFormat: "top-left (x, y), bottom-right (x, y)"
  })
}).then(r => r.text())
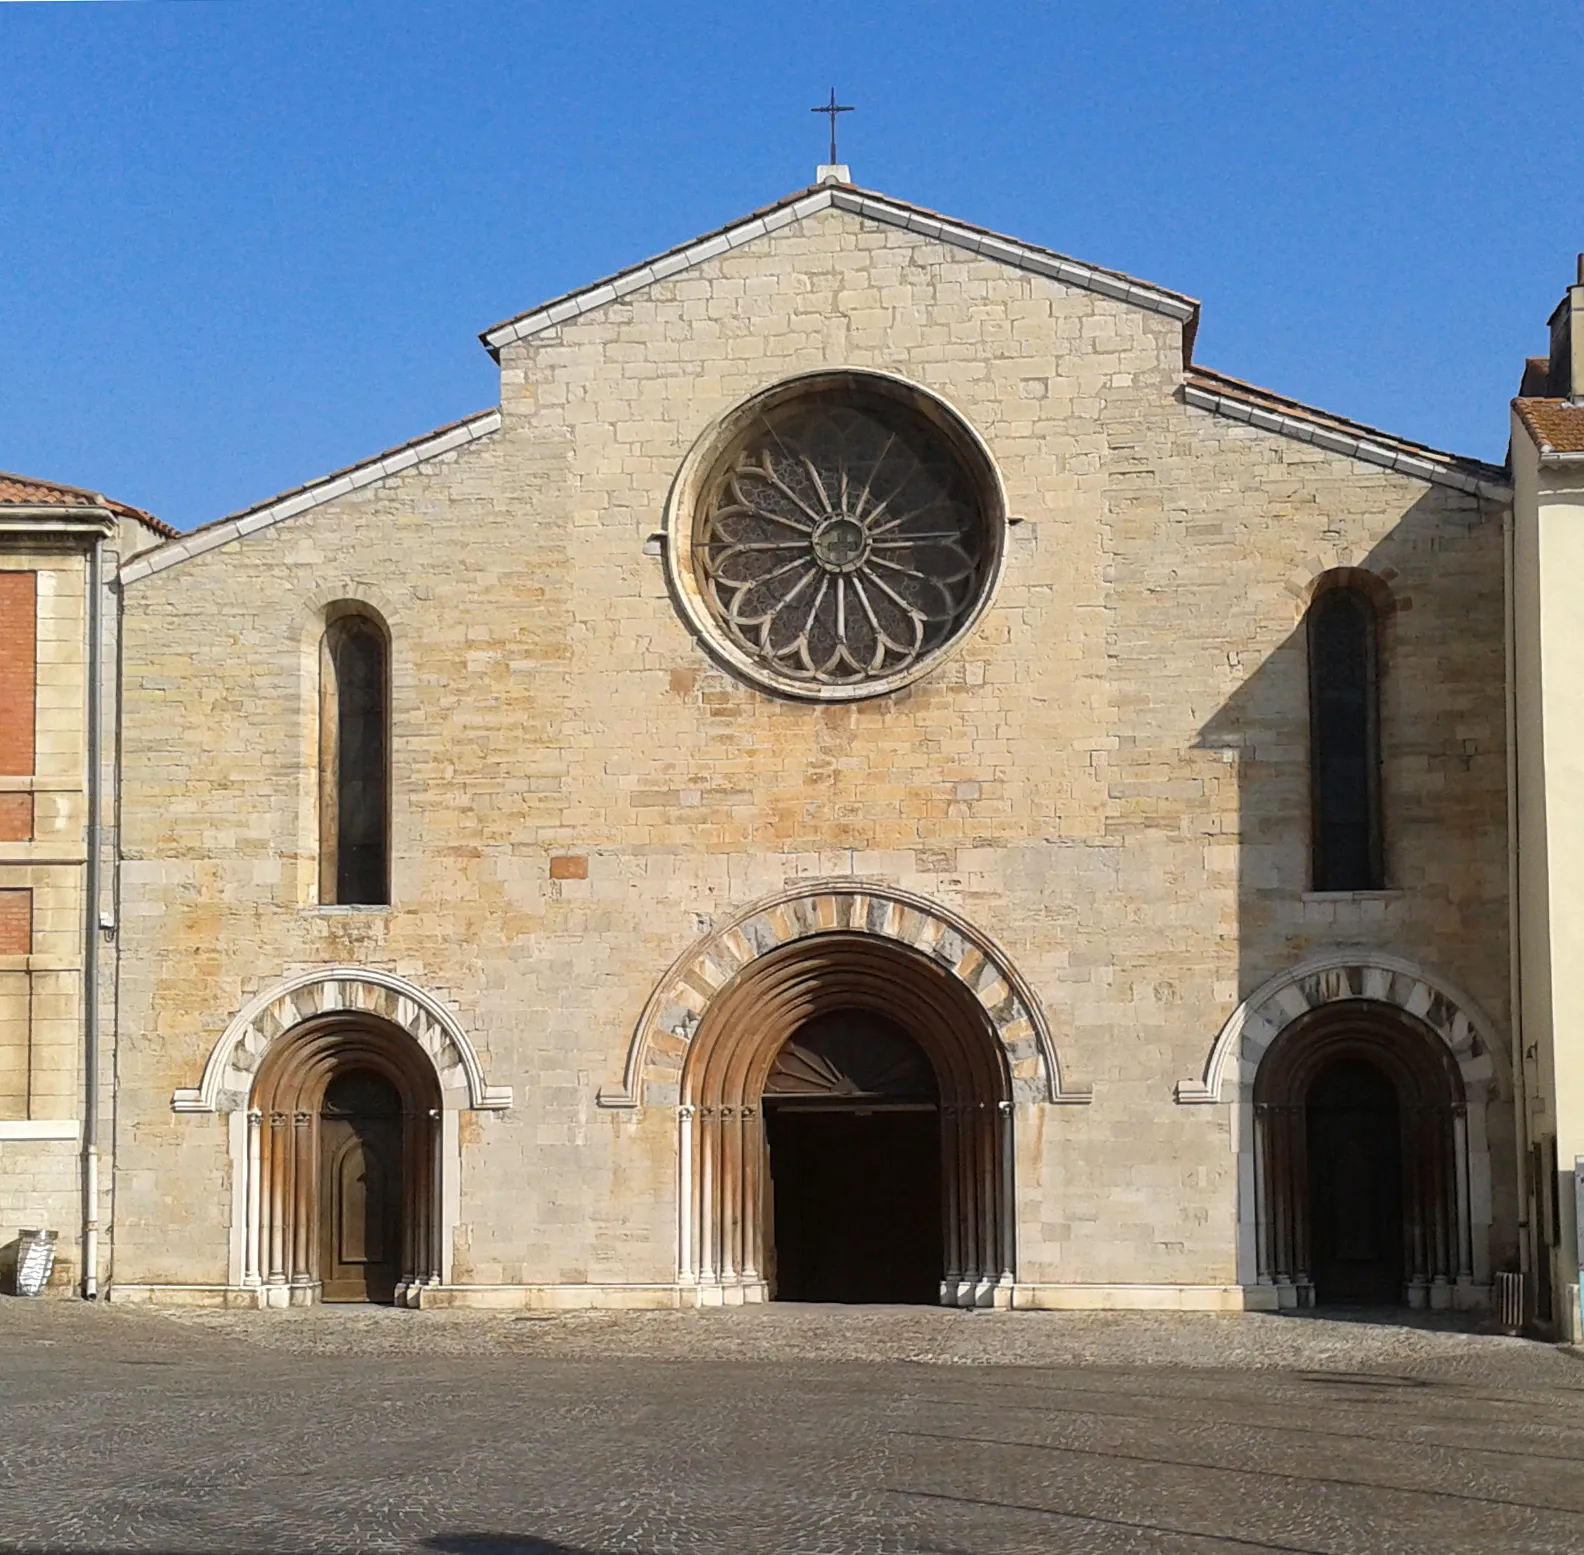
top-left (242, 1015), bottom-right (444, 1306)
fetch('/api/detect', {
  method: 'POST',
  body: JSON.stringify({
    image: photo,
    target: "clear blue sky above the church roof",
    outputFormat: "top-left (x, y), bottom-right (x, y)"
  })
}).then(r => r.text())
top-left (0, 0), bottom-right (1584, 529)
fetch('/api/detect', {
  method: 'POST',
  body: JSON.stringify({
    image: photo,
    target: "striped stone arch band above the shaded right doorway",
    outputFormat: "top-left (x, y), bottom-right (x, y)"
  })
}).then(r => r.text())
top-left (1177, 950), bottom-right (1508, 1102)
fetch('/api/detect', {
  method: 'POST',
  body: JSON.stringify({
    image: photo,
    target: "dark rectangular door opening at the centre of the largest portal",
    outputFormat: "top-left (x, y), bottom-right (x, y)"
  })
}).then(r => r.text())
top-left (765, 1104), bottom-right (944, 1303)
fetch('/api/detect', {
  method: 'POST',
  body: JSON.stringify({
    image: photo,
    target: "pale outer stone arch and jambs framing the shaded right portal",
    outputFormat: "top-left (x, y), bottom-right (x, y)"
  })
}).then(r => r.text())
top-left (1177, 950), bottom-right (1510, 1305)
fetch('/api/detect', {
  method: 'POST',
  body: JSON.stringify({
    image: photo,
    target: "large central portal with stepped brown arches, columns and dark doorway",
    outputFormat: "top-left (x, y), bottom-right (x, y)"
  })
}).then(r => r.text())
top-left (681, 931), bottom-right (1014, 1306)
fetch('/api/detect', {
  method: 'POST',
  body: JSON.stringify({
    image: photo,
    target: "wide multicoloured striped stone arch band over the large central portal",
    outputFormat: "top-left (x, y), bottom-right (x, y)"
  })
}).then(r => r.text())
top-left (599, 880), bottom-right (1093, 1107)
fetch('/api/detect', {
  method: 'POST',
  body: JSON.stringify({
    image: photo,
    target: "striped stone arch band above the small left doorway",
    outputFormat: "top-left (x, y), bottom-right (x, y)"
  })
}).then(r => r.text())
top-left (171, 966), bottom-right (512, 1112)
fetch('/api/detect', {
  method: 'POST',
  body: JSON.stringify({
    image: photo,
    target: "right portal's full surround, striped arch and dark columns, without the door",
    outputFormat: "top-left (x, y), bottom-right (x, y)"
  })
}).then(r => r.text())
top-left (1177, 950), bottom-right (1510, 1308)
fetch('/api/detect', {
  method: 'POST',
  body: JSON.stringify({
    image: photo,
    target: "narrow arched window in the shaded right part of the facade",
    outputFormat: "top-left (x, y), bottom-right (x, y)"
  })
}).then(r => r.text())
top-left (1308, 587), bottom-right (1384, 892)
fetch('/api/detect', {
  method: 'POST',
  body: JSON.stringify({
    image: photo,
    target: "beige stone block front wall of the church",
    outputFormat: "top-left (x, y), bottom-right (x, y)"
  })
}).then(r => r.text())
top-left (116, 212), bottom-right (1514, 1304)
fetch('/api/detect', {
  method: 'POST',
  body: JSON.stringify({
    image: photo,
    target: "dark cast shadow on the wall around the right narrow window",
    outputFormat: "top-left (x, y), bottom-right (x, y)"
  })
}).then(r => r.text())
top-left (1191, 489), bottom-right (1517, 1298)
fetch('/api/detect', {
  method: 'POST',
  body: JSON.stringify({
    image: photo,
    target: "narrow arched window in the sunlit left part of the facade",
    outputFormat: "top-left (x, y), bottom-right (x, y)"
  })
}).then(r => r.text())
top-left (320, 614), bottom-right (390, 906)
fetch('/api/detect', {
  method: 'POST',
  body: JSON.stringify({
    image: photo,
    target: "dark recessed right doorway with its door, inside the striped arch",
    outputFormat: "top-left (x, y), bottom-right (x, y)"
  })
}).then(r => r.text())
top-left (1255, 999), bottom-right (1472, 1306)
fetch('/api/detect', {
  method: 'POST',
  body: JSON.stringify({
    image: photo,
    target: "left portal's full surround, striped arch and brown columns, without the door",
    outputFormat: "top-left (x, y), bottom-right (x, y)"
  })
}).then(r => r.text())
top-left (171, 966), bottom-right (512, 1306)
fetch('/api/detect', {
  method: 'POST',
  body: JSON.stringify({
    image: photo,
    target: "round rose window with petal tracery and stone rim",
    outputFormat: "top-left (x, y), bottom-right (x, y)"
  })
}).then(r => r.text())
top-left (665, 372), bottom-right (1006, 701)
